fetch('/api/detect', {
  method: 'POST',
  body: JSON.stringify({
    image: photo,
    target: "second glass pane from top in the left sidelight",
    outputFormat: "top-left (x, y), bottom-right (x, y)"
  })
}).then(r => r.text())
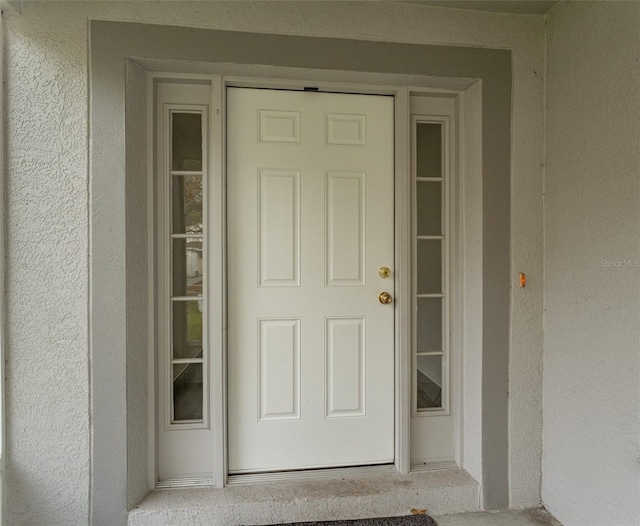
top-left (171, 175), bottom-right (202, 234)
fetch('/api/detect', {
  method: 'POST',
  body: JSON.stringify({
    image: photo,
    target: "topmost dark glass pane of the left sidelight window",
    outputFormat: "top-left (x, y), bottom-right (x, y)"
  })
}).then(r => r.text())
top-left (171, 112), bottom-right (202, 172)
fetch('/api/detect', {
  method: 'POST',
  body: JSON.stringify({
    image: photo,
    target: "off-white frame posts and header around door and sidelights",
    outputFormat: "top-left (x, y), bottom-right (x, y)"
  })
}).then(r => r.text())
top-left (147, 72), bottom-right (464, 488)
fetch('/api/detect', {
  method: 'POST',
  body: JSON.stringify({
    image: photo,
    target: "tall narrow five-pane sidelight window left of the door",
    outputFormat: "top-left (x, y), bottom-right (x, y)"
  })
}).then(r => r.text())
top-left (163, 105), bottom-right (208, 428)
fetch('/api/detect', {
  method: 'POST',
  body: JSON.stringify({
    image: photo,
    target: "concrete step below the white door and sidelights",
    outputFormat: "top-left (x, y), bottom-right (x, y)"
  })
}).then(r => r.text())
top-left (128, 469), bottom-right (480, 526)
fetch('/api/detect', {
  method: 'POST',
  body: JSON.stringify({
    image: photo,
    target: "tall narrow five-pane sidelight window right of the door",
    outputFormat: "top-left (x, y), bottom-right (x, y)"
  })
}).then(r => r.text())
top-left (412, 116), bottom-right (449, 416)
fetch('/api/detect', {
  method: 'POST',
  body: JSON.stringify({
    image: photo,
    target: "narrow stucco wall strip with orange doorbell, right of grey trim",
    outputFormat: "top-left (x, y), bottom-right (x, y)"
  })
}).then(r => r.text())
top-left (509, 12), bottom-right (545, 508)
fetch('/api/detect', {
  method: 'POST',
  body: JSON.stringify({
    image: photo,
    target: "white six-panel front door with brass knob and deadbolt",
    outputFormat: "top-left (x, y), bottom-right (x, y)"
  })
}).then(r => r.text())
top-left (227, 88), bottom-right (394, 473)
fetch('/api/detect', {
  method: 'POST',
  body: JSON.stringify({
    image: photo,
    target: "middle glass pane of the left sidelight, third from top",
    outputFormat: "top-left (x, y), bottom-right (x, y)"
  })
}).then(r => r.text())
top-left (171, 237), bottom-right (204, 296)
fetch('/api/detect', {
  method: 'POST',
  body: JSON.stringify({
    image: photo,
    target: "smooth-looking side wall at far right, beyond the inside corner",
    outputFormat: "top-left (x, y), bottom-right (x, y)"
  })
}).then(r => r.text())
top-left (542, 2), bottom-right (640, 526)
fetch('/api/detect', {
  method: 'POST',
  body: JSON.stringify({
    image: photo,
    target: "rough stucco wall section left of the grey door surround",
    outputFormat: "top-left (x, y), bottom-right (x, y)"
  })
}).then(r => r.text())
top-left (4, 6), bottom-right (89, 524)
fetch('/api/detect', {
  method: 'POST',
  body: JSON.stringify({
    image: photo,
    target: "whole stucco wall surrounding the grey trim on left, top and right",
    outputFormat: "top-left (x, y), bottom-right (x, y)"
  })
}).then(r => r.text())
top-left (5, 1), bottom-right (544, 524)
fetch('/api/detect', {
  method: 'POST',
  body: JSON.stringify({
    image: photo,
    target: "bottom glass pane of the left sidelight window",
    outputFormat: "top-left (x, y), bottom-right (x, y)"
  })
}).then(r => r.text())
top-left (172, 363), bottom-right (204, 422)
